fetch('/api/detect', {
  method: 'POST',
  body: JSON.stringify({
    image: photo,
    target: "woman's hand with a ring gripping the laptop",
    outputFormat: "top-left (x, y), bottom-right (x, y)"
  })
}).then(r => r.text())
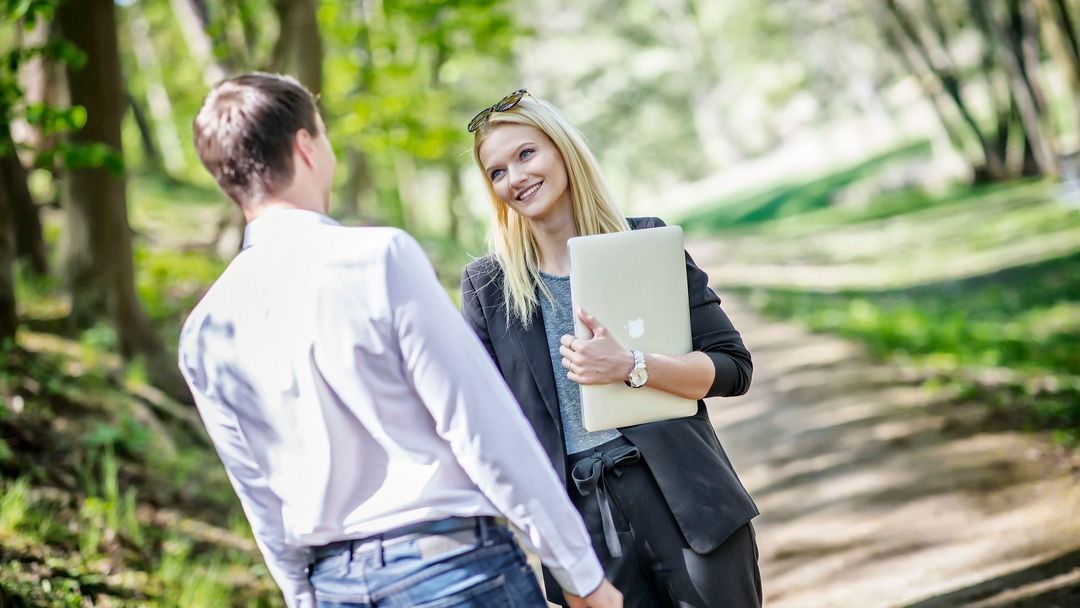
top-left (558, 308), bottom-right (634, 384)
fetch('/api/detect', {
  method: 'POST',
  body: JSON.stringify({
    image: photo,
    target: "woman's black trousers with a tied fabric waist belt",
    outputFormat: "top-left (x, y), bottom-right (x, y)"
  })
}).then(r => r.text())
top-left (544, 437), bottom-right (761, 608)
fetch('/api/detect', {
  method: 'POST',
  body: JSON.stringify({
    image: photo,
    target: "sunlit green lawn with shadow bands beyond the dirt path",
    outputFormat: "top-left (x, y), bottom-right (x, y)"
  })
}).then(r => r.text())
top-left (687, 147), bottom-right (1080, 445)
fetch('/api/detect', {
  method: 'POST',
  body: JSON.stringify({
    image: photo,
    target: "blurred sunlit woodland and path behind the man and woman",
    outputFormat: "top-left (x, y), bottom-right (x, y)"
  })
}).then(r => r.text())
top-left (0, 0), bottom-right (1080, 608)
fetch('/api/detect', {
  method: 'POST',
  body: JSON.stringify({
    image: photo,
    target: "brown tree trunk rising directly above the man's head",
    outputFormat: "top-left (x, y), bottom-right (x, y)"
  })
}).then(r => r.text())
top-left (271, 0), bottom-right (323, 95)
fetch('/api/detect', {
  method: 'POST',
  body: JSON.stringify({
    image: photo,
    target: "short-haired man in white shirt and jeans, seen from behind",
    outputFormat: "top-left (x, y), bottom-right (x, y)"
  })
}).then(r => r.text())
top-left (179, 73), bottom-right (622, 607)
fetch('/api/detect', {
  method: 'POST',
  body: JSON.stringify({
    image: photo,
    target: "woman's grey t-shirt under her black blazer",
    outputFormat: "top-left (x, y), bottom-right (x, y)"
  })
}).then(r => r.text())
top-left (540, 272), bottom-right (622, 454)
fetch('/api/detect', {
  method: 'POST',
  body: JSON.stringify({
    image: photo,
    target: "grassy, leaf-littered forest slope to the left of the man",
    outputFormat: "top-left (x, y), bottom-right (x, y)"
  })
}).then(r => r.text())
top-left (0, 179), bottom-right (280, 607)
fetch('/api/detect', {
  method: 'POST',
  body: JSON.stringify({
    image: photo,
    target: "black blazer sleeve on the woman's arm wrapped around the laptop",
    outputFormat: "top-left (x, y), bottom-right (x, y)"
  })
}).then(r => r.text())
top-left (632, 217), bottom-right (754, 397)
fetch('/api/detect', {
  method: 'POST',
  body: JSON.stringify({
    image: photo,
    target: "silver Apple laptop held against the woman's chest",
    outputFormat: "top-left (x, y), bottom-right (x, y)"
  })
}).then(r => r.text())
top-left (567, 226), bottom-right (698, 431)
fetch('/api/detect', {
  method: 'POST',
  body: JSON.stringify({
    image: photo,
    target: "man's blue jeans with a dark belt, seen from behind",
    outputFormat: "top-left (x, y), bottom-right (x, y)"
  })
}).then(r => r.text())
top-left (310, 518), bottom-right (546, 608)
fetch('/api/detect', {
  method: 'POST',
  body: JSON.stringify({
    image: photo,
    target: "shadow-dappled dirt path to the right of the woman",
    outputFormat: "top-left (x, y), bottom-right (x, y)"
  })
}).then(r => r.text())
top-left (710, 298), bottom-right (1080, 608)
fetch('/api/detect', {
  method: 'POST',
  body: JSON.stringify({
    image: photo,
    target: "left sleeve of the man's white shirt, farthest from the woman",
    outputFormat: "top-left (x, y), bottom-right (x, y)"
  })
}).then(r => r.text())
top-left (179, 330), bottom-right (315, 608)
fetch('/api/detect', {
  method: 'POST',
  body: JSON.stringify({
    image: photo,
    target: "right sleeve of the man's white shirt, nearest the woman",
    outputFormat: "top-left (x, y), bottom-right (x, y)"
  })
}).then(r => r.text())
top-left (387, 233), bottom-right (604, 595)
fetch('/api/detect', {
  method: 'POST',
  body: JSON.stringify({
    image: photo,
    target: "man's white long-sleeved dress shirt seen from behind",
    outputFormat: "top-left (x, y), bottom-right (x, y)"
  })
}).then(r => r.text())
top-left (179, 210), bottom-right (604, 607)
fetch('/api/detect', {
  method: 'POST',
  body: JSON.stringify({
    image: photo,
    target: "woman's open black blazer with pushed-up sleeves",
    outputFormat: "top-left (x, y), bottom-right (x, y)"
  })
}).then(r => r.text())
top-left (461, 217), bottom-right (758, 553)
